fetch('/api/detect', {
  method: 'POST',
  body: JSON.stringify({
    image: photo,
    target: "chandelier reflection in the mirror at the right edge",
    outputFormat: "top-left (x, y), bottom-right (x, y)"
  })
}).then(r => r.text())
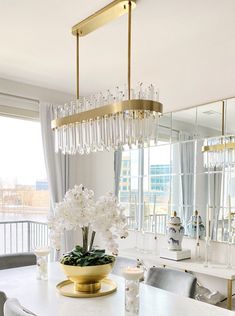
top-left (202, 101), bottom-right (235, 168)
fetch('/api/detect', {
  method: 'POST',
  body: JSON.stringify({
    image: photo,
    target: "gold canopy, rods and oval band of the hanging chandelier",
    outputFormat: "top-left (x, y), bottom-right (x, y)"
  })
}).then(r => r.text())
top-left (51, 0), bottom-right (163, 130)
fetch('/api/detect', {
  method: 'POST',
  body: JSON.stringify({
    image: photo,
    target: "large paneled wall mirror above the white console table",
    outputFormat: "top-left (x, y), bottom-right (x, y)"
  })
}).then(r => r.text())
top-left (119, 98), bottom-right (235, 241)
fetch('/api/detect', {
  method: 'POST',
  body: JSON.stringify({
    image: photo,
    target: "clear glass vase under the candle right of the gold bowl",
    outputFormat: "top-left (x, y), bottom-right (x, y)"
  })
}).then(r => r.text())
top-left (125, 280), bottom-right (139, 315)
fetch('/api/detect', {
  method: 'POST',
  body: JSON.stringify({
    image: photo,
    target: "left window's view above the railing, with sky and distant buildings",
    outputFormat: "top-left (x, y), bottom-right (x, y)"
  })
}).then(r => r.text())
top-left (0, 116), bottom-right (49, 222)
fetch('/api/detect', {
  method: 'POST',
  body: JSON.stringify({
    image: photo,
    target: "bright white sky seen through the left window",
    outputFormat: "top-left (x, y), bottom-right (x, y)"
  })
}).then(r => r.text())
top-left (0, 116), bottom-right (46, 186)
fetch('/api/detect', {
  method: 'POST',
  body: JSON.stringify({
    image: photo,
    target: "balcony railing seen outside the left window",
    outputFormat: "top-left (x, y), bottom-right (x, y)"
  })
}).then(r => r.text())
top-left (0, 221), bottom-right (49, 254)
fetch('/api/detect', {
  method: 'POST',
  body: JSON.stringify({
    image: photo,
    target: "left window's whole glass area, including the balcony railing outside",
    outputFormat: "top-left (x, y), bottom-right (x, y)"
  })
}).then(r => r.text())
top-left (0, 116), bottom-right (50, 254)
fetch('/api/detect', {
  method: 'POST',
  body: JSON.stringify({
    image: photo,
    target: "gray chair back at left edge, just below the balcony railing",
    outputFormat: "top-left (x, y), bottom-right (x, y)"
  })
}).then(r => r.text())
top-left (0, 253), bottom-right (37, 270)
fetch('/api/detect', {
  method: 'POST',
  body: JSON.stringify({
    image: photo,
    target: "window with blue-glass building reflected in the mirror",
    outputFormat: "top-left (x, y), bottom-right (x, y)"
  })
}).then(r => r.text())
top-left (119, 142), bottom-right (171, 233)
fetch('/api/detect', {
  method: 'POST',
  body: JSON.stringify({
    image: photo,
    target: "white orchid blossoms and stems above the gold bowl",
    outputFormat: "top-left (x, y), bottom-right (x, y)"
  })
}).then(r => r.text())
top-left (49, 185), bottom-right (128, 254)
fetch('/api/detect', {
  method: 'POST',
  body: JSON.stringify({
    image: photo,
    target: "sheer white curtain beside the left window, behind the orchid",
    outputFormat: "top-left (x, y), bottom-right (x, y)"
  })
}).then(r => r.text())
top-left (40, 104), bottom-right (80, 252)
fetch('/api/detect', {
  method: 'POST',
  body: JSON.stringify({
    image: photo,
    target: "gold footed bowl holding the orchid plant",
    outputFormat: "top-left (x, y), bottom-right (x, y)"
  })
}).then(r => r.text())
top-left (60, 262), bottom-right (114, 293)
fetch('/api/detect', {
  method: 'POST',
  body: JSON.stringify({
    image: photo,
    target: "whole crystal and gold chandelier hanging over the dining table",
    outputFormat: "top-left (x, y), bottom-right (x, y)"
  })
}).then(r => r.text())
top-left (51, 0), bottom-right (162, 154)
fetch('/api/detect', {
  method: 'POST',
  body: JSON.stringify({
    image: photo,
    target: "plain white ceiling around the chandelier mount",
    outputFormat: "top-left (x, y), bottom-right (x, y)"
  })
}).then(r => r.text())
top-left (0, 0), bottom-right (235, 109)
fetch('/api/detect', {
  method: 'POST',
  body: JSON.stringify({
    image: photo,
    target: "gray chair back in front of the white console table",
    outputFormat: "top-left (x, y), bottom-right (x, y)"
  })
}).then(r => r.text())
top-left (145, 267), bottom-right (197, 298)
